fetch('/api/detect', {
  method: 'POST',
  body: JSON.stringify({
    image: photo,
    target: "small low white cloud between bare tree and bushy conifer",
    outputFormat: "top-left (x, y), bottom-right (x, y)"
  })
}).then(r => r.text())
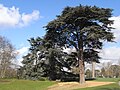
top-left (17, 47), bottom-right (29, 65)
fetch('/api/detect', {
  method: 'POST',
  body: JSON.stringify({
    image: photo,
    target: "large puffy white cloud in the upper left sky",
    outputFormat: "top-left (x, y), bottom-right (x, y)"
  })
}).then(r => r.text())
top-left (0, 4), bottom-right (40, 27)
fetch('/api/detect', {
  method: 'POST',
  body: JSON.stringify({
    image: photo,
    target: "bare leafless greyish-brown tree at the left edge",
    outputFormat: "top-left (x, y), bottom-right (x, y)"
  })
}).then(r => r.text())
top-left (0, 36), bottom-right (15, 78)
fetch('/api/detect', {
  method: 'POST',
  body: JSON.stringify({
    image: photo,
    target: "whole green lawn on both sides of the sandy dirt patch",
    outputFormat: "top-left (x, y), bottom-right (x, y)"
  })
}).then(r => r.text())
top-left (0, 78), bottom-right (120, 90)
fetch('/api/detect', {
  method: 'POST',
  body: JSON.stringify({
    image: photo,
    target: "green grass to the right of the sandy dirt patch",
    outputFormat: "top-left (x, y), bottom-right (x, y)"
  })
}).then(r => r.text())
top-left (75, 78), bottom-right (120, 90)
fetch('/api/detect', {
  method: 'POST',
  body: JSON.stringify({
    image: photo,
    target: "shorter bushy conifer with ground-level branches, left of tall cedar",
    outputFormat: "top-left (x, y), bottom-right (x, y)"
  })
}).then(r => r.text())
top-left (18, 37), bottom-right (76, 80)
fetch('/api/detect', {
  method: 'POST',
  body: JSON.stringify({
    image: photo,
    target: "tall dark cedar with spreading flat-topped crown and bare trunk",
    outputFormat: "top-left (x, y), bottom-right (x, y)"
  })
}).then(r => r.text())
top-left (45, 5), bottom-right (114, 84)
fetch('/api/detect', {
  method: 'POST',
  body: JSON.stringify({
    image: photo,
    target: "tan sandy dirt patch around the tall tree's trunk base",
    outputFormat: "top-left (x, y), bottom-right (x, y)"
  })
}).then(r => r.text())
top-left (48, 81), bottom-right (114, 90)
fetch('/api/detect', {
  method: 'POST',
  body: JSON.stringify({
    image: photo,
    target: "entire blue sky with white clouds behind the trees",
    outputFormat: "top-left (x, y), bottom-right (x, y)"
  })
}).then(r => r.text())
top-left (0, 0), bottom-right (120, 63)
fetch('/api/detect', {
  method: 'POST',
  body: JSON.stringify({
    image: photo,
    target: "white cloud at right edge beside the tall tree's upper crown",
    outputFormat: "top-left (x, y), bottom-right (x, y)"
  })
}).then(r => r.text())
top-left (110, 16), bottom-right (120, 41)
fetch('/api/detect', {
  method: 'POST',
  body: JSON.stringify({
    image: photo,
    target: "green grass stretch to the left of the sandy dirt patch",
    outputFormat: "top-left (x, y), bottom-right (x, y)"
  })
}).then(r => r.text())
top-left (0, 79), bottom-right (55, 90)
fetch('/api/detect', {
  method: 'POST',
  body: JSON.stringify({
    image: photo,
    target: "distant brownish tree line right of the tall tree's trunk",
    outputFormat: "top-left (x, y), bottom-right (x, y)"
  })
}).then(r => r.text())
top-left (85, 62), bottom-right (120, 79)
